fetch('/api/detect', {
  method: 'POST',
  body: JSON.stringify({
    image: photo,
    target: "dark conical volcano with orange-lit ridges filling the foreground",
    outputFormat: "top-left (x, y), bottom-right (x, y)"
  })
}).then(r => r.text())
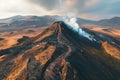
top-left (0, 21), bottom-right (120, 80)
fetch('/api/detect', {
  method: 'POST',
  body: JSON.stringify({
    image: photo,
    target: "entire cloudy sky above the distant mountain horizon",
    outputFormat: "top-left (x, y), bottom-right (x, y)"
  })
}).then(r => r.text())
top-left (0, 0), bottom-right (120, 20)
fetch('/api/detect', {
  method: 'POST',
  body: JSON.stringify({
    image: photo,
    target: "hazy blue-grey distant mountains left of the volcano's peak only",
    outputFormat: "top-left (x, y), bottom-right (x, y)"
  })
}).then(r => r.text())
top-left (0, 16), bottom-right (52, 28)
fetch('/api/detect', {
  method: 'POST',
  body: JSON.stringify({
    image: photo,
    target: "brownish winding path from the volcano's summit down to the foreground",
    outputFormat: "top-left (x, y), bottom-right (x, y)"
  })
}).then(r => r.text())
top-left (43, 23), bottom-right (72, 80)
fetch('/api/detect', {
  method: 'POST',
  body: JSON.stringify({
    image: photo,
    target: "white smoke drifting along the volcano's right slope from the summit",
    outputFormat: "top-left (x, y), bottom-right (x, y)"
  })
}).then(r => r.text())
top-left (56, 17), bottom-right (96, 41)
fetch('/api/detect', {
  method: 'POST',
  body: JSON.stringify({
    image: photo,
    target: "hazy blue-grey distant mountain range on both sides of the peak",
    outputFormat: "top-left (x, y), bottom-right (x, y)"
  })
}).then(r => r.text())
top-left (0, 15), bottom-right (120, 31)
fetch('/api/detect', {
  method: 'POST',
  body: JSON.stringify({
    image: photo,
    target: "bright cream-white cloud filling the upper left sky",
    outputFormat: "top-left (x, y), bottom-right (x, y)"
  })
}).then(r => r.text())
top-left (0, 0), bottom-right (52, 18)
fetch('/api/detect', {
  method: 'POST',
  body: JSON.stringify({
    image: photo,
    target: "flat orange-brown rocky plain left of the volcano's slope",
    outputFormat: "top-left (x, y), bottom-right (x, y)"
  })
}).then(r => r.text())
top-left (0, 27), bottom-right (47, 50)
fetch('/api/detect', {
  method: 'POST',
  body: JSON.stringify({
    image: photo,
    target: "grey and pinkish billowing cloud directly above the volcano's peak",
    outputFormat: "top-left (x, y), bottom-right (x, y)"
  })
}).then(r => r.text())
top-left (28, 0), bottom-right (99, 16)
